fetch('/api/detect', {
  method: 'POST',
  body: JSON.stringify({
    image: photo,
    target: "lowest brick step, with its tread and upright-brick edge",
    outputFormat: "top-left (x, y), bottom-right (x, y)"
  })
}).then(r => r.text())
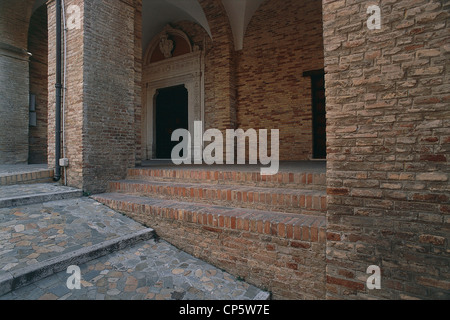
top-left (92, 193), bottom-right (326, 245)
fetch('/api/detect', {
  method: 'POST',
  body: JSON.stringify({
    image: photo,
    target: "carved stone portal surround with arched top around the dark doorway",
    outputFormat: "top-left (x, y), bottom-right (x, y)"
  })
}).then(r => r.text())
top-left (142, 26), bottom-right (205, 160)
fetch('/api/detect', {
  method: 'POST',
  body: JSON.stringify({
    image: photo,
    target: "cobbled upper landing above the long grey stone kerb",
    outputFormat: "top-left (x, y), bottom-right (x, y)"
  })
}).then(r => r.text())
top-left (0, 196), bottom-right (144, 276)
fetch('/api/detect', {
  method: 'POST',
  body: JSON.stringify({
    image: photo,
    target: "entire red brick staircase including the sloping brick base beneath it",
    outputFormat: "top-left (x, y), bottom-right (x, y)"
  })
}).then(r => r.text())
top-left (92, 167), bottom-right (327, 299)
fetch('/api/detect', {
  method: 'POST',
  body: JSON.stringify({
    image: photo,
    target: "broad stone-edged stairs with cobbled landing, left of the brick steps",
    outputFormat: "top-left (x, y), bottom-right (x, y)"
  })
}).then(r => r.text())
top-left (0, 166), bottom-right (154, 296)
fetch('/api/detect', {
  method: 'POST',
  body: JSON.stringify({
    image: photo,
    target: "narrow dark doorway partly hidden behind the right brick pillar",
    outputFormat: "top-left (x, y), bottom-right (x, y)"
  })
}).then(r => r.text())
top-left (304, 70), bottom-right (327, 159)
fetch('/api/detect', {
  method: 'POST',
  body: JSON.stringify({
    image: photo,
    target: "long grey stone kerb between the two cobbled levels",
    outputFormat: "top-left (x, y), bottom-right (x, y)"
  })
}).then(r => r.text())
top-left (0, 228), bottom-right (155, 296)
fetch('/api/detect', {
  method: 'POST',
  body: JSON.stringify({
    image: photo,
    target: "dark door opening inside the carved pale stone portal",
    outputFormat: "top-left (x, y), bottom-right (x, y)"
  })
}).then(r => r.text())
top-left (155, 85), bottom-right (189, 159)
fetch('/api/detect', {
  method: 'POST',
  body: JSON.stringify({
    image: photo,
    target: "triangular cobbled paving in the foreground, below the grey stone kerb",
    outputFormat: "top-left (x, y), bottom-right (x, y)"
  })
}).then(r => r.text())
top-left (0, 240), bottom-right (267, 300)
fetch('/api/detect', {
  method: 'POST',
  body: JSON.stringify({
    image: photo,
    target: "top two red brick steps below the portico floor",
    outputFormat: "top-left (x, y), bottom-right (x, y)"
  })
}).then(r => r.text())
top-left (95, 168), bottom-right (326, 216)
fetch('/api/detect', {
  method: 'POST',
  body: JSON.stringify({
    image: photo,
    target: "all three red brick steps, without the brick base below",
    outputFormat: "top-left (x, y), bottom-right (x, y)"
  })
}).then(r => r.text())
top-left (93, 168), bottom-right (327, 239)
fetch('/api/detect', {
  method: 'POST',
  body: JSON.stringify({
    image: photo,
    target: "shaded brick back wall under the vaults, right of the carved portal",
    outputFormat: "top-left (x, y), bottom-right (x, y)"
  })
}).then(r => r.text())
top-left (161, 0), bottom-right (324, 160)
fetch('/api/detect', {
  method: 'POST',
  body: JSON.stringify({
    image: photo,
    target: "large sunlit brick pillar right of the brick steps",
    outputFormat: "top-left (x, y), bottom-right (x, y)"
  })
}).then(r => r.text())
top-left (323, 0), bottom-right (450, 299)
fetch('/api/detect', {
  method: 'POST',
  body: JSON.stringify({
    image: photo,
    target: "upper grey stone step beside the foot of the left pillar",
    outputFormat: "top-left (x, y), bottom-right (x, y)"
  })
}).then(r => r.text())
top-left (0, 183), bottom-right (83, 208)
